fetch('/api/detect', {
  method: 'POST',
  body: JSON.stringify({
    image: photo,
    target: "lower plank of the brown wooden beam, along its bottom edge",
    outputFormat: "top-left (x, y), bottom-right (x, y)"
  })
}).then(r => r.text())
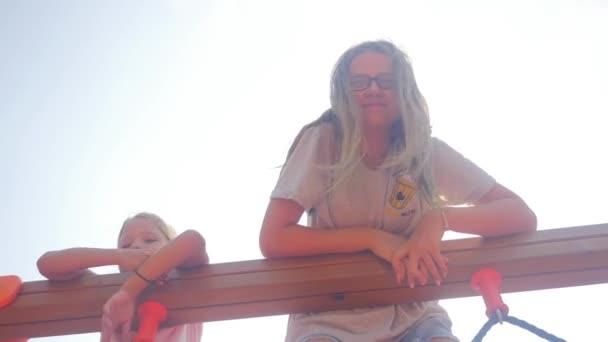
top-left (0, 268), bottom-right (608, 338)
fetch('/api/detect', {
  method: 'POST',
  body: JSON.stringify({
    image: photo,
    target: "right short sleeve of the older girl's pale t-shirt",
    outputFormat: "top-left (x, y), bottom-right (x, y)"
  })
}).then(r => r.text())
top-left (433, 138), bottom-right (496, 205)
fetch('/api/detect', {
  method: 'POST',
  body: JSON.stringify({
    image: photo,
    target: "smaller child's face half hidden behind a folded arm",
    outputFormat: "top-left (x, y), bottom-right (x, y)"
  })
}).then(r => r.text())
top-left (118, 218), bottom-right (169, 254)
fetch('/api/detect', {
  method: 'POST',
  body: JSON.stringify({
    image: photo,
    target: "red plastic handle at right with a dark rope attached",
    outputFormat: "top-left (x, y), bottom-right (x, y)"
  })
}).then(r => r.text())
top-left (471, 268), bottom-right (509, 317)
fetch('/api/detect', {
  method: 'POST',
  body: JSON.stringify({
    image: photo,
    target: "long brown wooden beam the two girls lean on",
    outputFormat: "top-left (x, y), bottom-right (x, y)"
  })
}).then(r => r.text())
top-left (0, 224), bottom-right (608, 338)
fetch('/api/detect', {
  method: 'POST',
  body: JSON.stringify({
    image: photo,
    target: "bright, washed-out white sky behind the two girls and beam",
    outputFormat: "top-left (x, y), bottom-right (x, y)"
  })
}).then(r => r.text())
top-left (0, 0), bottom-right (608, 341)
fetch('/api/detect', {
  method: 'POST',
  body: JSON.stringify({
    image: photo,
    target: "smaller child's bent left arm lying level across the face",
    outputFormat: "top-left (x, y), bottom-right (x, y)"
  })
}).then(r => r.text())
top-left (36, 247), bottom-right (149, 280)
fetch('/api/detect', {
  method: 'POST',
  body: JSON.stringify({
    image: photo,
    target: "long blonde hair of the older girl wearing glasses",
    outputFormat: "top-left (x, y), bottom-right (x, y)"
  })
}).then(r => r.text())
top-left (287, 40), bottom-right (436, 205)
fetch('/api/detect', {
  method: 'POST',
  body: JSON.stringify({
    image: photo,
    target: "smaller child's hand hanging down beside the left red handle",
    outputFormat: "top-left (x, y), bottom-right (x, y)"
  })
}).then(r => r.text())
top-left (101, 289), bottom-right (135, 342)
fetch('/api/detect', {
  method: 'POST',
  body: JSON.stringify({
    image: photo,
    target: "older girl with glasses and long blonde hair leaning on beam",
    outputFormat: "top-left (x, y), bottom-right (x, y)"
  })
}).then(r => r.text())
top-left (260, 41), bottom-right (536, 342)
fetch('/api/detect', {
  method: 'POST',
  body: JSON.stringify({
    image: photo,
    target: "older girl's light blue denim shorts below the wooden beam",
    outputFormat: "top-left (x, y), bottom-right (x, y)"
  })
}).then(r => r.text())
top-left (301, 316), bottom-right (458, 342)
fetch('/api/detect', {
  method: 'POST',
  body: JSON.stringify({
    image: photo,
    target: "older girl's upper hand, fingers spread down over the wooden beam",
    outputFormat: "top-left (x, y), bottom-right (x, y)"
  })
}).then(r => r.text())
top-left (392, 209), bottom-right (448, 288)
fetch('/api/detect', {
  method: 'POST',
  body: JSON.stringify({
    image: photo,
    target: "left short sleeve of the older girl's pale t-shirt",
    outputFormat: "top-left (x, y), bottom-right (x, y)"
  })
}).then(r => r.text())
top-left (271, 124), bottom-right (332, 211)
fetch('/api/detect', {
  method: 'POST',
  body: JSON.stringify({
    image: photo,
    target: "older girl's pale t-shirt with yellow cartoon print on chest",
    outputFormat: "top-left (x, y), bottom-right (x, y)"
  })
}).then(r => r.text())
top-left (271, 123), bottom-right (496, 341)
